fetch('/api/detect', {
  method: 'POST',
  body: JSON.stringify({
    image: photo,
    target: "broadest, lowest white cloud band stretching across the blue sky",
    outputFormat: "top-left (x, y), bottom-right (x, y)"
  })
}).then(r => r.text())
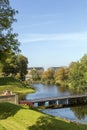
top-left (19, 32), bottom-right (87, 43)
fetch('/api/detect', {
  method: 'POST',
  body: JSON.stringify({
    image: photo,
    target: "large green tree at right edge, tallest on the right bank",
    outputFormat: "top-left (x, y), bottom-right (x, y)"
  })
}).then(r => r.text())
top-left (69, 54), bottom-right (87, 89)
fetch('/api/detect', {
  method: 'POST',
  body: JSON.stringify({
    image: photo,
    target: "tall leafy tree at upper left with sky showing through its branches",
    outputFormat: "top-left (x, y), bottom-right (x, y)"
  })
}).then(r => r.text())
top-left (0, 0), bottom-right (19, 62)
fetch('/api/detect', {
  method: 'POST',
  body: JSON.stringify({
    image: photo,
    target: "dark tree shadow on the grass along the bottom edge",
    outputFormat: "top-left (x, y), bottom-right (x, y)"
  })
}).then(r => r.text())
top-left (28, 116), bottom-right (87, 130)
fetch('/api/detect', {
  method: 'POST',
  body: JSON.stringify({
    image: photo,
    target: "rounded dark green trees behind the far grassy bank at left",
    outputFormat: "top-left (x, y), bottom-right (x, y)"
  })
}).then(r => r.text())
top-left (2, 52), bottom-right (28, 80)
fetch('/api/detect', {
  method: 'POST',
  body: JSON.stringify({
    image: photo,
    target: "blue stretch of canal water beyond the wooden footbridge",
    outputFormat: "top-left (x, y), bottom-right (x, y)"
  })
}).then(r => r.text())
top-left (26, 84), bottom-right (70, 100)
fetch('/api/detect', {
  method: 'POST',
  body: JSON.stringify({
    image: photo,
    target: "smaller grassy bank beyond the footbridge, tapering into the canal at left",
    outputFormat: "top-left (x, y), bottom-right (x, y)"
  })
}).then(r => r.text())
top-left (0, 77), bottom-right (35, 98)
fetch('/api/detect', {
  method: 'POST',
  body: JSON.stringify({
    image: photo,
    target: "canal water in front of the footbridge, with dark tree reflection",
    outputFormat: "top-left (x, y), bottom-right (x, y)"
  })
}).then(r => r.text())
top-left (43, 106), bottom-right (87, 124)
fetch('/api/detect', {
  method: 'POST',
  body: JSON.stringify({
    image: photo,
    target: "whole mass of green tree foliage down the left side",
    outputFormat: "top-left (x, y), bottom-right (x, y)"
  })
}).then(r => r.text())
top-left (0, 0), bottom-right (28, 80)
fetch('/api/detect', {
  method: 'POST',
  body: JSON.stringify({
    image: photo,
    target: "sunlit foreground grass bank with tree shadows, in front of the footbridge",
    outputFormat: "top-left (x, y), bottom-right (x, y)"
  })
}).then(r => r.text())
top-left (0, 103), bottom-right (87, 130)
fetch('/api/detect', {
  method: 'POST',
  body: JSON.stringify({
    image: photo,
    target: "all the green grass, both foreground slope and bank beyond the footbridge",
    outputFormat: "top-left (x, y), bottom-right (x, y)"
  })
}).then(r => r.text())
top-left (0, 78), bottom-right (87, 130)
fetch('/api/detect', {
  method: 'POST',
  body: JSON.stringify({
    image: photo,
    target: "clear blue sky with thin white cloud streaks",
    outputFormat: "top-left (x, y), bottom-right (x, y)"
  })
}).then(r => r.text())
top-left (10, 0), bottom-right (87, 69)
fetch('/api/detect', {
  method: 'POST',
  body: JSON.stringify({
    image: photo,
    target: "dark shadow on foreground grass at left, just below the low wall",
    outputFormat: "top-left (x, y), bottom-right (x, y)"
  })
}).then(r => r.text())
top-left (0, 102), bottom-right (22, 119)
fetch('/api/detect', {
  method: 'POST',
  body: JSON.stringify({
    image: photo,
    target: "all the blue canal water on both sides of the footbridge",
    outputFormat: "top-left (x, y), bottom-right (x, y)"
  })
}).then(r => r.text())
top-left (26, 84), bottom-right (87, 123)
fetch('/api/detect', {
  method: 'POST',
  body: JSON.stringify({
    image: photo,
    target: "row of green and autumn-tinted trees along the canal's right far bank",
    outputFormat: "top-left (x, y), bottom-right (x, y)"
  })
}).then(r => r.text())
top-left (31, 54), bottom-right (87, 91)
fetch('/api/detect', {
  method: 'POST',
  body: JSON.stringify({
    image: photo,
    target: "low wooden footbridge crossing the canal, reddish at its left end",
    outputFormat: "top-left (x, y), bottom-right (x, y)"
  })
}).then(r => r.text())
top-left (19, 94), bottom-right (87, 107)
